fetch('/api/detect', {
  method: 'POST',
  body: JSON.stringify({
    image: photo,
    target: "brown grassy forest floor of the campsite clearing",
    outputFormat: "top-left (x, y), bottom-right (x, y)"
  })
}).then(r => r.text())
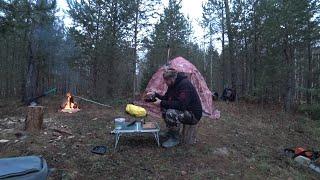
top-left (0, 97), bottom-right (320, 180)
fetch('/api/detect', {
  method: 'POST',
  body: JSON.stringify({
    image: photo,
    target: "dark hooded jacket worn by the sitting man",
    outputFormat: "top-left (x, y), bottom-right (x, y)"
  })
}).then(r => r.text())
top-left (156, 72), bottom-right (202, 120)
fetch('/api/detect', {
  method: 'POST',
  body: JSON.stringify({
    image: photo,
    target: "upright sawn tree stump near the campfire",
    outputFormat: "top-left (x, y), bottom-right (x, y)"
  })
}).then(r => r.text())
top-left (25, 106), bottom-right (44, 132)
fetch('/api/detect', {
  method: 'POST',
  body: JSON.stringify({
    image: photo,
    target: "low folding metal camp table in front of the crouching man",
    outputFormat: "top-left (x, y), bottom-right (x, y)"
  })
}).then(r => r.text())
top-left (113, 121), bottom-right (160, 149)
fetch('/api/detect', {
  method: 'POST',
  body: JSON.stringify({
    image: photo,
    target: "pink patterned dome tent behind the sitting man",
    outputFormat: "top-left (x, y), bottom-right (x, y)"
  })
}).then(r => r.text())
top-left (136, 57), bottom-right (220, 119)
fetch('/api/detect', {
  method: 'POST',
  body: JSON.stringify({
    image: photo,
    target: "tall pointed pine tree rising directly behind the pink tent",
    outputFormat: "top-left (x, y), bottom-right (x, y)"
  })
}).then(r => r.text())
top-left (144, 0), bottom-right (191, 86)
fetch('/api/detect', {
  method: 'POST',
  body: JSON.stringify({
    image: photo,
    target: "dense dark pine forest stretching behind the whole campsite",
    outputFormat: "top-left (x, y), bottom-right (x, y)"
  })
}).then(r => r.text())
top-left (0, 0), bottom-right (320, 116)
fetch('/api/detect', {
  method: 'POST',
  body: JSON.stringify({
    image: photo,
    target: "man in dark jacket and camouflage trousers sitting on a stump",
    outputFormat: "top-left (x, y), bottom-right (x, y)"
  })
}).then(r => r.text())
top-left (147, 69), bottom-right (202, 148)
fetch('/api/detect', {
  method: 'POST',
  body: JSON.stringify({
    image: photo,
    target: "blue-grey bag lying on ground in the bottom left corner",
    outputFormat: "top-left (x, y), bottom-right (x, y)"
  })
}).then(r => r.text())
top-left (0, 156), bottom-right (48, 180)
